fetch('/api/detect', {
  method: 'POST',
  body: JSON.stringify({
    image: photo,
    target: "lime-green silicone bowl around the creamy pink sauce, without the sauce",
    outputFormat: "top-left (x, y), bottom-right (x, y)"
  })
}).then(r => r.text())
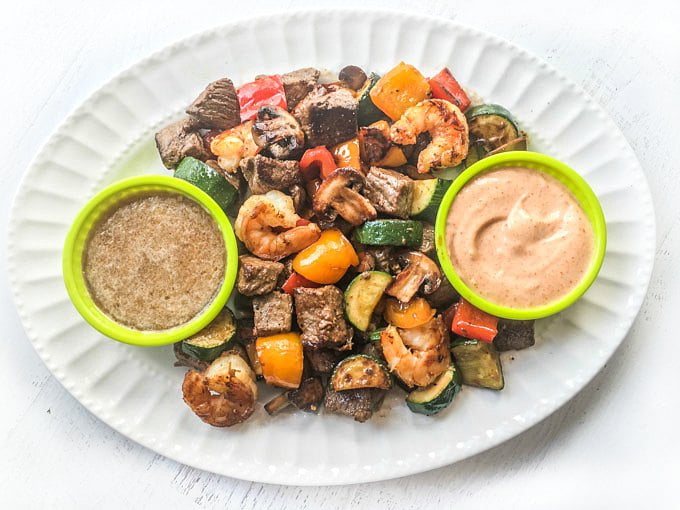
top-left (435, 151), bottom-right (607, 320)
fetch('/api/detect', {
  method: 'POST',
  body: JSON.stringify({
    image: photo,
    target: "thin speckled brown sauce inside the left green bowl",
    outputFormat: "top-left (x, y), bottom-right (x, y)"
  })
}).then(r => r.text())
top-left (83, 193), bottom-right (225, 331)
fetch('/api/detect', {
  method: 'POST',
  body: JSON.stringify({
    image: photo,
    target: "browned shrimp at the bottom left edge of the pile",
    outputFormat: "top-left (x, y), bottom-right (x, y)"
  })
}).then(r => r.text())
top-left (182, 351), bottom-right (257, 427)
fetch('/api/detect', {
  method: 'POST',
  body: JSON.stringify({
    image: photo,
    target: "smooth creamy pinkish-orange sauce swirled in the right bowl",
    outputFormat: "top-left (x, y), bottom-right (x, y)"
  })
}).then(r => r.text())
top-left (446, 168), bottom-right (594, 308)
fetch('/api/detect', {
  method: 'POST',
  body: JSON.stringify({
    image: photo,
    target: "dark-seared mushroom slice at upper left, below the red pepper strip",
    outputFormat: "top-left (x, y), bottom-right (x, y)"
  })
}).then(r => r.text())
top-left (252, 105), bottom-right (305, 159)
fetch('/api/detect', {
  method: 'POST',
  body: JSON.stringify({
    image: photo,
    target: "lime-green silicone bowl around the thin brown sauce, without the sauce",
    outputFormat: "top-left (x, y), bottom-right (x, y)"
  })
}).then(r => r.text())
top-left (62, 175), bottom-right (238, 346)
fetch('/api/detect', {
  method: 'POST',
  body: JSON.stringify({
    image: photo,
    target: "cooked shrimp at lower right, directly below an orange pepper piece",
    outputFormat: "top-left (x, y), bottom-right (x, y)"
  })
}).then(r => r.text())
top-left (380, 316), bottom-right (451, 386)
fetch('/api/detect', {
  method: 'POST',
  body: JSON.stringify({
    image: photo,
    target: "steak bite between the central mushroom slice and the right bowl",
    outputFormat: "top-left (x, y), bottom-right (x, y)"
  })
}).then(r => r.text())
top-left (364, 166), bottom-right (413, 219)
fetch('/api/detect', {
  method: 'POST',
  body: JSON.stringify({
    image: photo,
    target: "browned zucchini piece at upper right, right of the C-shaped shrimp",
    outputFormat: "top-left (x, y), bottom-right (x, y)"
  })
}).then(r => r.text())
top-left (465, 104), bottom-right (520, 152)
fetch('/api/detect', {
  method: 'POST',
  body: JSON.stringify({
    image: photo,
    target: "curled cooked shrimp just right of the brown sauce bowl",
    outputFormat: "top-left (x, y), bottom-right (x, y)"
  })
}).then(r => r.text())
top-left (234, 190), bottom-right (321, 260)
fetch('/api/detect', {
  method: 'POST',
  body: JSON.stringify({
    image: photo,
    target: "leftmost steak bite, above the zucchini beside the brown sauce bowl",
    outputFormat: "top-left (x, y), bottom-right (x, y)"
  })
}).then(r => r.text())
top-left (156, 119), bottom-right (212, 168)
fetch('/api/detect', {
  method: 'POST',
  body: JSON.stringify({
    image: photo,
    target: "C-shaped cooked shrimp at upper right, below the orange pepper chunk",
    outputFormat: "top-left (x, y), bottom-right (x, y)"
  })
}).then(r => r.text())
top-left (390, 99), bottom-right (469, 173)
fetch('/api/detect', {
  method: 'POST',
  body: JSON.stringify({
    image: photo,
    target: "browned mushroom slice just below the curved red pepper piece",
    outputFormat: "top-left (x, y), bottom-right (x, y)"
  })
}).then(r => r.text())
top-left (314, 167), bottom-right (378, 225)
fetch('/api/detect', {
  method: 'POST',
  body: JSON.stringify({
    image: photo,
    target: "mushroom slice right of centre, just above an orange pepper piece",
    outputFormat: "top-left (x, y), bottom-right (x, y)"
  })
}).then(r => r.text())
top-left (386, 251), bottom-right (442, 303)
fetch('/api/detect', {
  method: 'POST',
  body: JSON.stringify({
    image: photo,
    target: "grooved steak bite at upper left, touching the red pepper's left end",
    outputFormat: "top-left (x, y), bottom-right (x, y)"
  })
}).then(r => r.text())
top-left (186, 78), bottom-right (241, 131)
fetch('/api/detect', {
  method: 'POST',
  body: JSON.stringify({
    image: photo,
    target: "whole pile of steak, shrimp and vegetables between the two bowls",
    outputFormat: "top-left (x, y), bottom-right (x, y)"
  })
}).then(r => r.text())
top-left (156, 63), bottom-right (534, 426)
